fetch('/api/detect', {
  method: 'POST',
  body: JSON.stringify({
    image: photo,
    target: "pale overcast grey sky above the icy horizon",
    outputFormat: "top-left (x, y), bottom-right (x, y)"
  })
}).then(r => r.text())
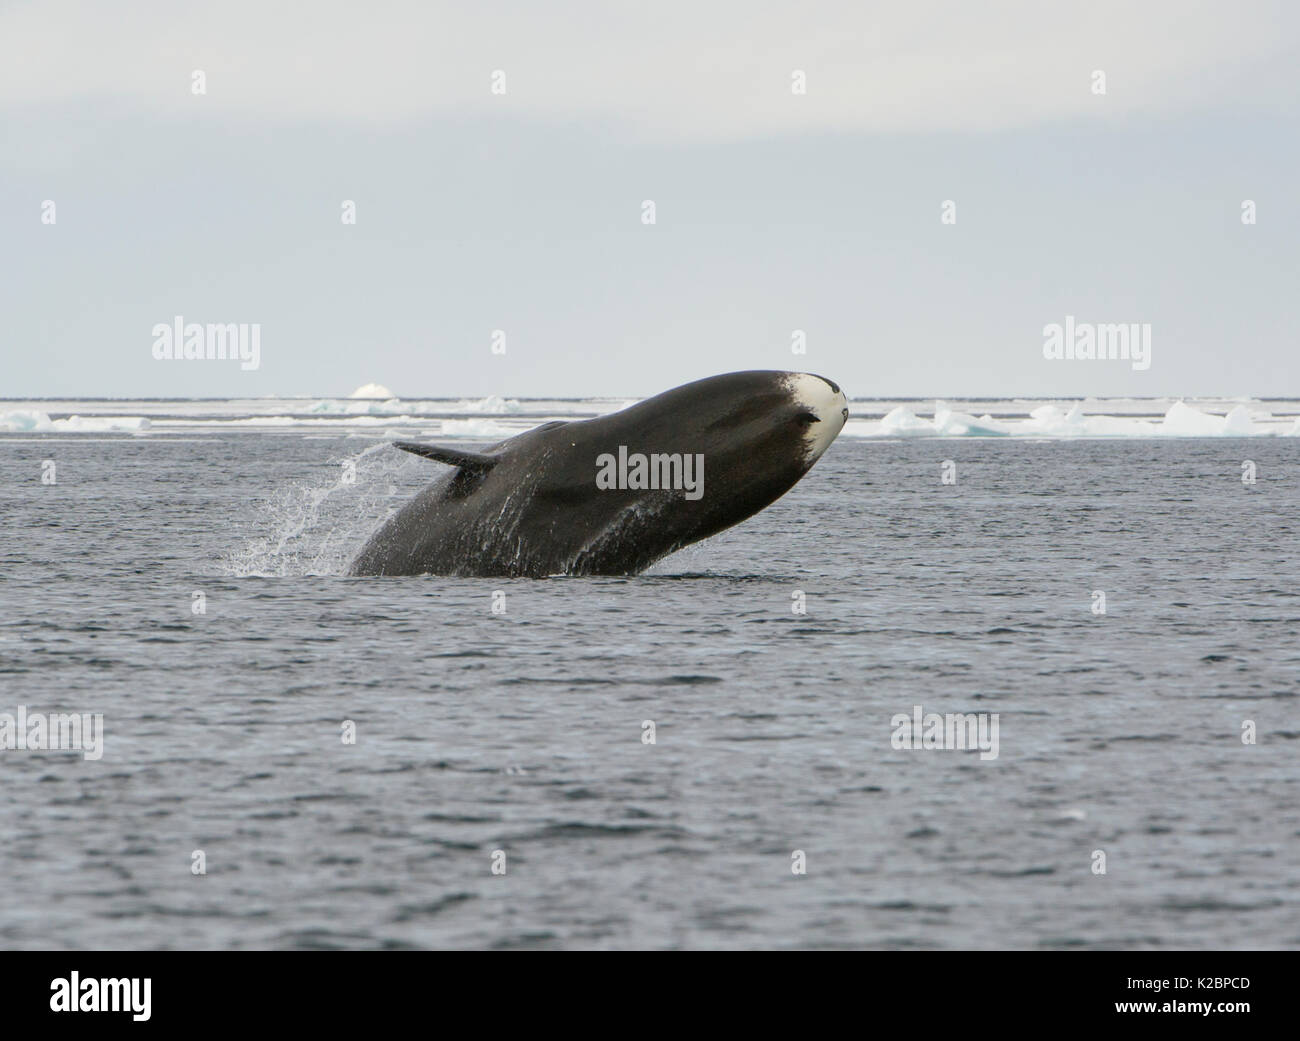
top-left (0, 0), bottom-right (1300, 398)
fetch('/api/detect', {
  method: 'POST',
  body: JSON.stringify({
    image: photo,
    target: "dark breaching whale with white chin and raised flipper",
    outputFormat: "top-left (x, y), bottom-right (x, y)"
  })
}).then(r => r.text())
top-left (348, 372), bottom-right (849, 578)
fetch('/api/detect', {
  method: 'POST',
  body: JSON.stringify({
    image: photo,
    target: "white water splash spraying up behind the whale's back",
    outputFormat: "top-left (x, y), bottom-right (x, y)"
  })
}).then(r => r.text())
top-left (218, 443), bottom-right (410, 578)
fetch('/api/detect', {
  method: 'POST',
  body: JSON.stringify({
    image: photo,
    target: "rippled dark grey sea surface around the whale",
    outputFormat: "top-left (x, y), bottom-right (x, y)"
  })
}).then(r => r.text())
top-left (0, 431), bottom-right (1300, 947)
